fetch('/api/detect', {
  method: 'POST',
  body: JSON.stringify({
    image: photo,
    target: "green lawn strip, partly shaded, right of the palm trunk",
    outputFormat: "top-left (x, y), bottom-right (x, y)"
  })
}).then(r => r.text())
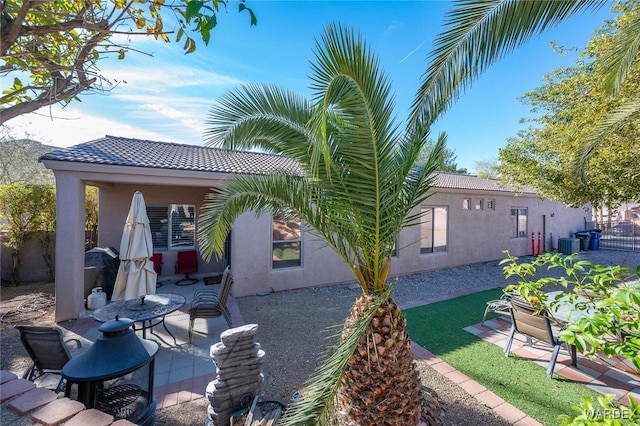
top-left (404, 289), bottom-right (599, 425)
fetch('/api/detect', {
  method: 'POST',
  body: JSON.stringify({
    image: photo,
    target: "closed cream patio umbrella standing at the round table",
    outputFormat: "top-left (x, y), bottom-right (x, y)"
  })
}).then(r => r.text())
top-left (111, 191), bottom-right (157, 300)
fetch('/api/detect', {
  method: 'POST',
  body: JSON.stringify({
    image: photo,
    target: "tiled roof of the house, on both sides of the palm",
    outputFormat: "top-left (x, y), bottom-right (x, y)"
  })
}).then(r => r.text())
top-left (40, 135), bottom-right (535, 193)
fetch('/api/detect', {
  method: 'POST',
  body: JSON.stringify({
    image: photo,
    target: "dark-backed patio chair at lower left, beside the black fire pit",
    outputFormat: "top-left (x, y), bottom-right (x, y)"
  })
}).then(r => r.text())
top-left (14, 325), bottom-right (82, 392)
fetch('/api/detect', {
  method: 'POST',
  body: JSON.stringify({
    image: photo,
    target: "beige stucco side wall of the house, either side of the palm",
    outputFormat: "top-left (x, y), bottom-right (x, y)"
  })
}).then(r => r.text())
top-left (231, 190), bottom-right (590, 297)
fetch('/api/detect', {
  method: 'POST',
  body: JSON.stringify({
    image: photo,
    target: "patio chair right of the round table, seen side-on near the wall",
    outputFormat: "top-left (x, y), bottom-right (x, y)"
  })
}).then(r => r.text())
top-left (189, 266), bottom-right (233, 342)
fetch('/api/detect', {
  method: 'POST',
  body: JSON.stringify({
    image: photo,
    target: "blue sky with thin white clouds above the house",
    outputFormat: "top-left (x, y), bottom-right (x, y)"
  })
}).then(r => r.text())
top-left (6, 0), bottom-right (612, 172)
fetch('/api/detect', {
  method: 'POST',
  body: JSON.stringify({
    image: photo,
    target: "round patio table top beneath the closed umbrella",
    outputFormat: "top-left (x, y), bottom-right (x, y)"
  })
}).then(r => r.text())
top-left (92, 293), bottom-right (187, 322)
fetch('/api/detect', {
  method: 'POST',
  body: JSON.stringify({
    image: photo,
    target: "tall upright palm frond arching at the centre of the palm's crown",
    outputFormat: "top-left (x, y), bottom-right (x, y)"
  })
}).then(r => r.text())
top-left (312, 25), bottom-right (418, 282)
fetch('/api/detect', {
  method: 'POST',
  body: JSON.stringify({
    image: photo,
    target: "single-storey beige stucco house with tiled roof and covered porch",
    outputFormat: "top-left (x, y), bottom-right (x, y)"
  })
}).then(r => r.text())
top-left (40, 136), bottom-right (591, 321)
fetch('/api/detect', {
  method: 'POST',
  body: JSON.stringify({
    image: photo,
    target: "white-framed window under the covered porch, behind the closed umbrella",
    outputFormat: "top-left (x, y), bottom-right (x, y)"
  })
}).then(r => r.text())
top-left (147, 204), bottom-right (196, 251)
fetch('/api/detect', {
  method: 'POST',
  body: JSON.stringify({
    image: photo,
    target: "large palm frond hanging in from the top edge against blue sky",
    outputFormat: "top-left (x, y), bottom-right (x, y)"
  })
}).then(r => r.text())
top-left (411, 0), bottom-right (607, 125)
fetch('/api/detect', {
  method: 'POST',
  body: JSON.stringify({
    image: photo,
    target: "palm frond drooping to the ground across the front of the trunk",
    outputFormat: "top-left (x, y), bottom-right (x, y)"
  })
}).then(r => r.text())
top-left (278, 280), bottom-right (397, 426)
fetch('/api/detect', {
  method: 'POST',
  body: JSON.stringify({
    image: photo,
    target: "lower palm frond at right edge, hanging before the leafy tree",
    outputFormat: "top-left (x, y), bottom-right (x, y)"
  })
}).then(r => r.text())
top-left (573, 98), bottom-right (640, 179)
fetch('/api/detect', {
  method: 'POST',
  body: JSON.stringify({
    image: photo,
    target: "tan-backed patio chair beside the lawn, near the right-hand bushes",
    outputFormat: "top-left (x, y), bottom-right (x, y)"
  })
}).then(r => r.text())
top-left (504, 298), bottom-right (577, 378)
